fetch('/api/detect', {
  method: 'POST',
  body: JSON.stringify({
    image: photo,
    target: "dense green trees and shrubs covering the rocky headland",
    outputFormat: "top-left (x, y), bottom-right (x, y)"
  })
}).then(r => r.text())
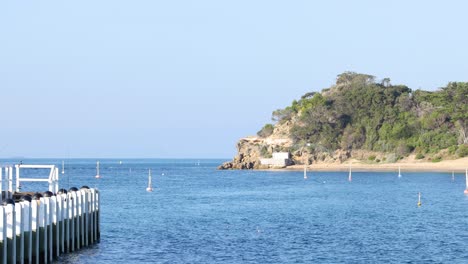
top-left (262, 72), bottom-right (468, 160)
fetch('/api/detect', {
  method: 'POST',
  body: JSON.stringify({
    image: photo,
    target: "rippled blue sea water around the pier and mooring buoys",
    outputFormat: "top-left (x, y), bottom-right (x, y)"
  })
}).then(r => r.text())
top-left (4, 159), bottom-right (468, 263)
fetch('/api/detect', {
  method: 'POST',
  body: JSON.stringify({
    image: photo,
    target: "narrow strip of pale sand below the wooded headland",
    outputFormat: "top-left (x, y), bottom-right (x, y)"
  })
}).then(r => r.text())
top-left (286, 157), bottom-right (468, 173)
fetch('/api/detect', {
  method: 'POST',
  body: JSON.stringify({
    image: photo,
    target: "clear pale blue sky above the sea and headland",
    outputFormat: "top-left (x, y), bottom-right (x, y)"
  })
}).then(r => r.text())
top-left (0, 0), bottom-right (468, 159)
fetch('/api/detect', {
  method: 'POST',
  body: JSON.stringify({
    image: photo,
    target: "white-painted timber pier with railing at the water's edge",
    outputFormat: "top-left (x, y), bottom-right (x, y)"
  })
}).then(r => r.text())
top-left (0, 164), bottom-right (100, 264)
